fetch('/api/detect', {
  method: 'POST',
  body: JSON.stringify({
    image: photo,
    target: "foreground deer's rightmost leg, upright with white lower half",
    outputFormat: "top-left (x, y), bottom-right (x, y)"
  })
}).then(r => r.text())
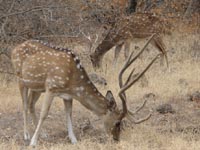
top-left (63, 99), bottom-right (77, 144)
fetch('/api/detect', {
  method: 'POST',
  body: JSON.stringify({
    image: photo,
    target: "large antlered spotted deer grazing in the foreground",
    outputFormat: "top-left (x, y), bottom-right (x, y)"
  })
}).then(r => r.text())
top-left (12, 34), bottom-right (160, 146)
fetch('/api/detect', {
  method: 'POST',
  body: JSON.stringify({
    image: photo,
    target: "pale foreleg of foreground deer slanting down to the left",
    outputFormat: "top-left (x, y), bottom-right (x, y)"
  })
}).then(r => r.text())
top-left (30, 91), bottom-right (53, 146)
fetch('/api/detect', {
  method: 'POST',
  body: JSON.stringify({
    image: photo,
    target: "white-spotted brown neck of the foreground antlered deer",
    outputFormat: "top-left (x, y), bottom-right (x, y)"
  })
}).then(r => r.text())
top-left (70, 68), bottom-right (108, 116)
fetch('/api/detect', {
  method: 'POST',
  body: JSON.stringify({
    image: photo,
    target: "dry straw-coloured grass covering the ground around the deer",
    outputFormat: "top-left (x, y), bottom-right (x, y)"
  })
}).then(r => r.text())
top-left (0, 32), bottom-right (200, 150)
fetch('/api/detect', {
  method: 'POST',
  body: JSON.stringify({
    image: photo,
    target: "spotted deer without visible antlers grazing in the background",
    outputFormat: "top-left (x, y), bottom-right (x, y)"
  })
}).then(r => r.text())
top-left (90, 13), bottom-right (168, 68)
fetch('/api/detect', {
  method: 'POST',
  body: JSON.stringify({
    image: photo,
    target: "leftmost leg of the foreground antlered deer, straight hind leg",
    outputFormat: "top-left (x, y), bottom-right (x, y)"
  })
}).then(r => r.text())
top-left (19, 84), bottom-right (30, 140)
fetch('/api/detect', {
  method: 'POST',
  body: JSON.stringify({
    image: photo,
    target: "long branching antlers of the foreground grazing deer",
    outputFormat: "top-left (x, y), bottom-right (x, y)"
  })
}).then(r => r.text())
top-left (118, 34), bottom-right (163, 124)
